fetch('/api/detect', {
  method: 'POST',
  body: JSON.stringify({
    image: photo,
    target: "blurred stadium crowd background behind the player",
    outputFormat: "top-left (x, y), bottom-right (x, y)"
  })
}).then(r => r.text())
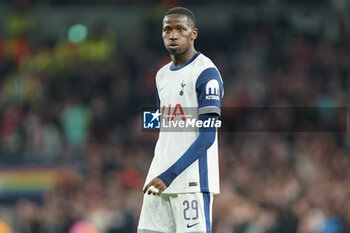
top-left (0, 0), bottom-right (350, 233)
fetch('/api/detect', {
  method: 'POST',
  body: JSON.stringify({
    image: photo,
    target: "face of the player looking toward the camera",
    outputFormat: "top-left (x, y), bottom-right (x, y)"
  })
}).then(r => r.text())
top-left (162, 14), bottom-right (197, 55)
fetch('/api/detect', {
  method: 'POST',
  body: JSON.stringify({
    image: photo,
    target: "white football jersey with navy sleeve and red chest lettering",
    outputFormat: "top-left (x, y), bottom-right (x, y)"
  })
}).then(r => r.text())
top-left (146, 52), bottom-right (223, 194)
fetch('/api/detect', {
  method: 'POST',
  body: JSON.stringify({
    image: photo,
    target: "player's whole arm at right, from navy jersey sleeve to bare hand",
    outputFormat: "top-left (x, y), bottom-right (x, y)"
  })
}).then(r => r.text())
top-left (144, 68), bottom-right (223, 194)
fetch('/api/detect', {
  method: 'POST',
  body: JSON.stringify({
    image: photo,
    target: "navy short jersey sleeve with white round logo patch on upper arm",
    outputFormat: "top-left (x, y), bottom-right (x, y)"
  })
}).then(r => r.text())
top-left (196, 67), bottom-right (224, 116)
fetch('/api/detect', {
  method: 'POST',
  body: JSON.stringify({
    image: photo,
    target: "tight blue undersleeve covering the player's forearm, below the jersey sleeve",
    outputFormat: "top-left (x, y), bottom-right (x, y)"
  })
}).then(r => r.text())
top-left (158, 114), bottom-right (218, 187)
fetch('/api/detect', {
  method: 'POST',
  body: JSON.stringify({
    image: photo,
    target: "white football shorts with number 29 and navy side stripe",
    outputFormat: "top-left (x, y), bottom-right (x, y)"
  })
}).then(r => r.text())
top-left (137, 193), bottom-right (213, 233)
